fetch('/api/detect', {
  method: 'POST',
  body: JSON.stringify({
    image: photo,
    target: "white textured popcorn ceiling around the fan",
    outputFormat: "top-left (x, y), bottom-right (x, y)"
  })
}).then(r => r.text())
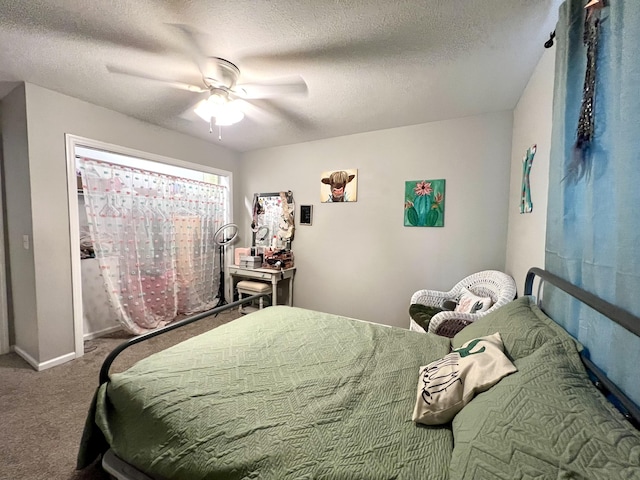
top-left (0, 0), bottom-right (562, 151)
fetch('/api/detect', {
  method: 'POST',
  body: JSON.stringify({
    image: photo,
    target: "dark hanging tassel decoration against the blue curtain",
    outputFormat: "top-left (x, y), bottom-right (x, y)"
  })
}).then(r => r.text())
top-left (565, 0), bottom-right (604, 183)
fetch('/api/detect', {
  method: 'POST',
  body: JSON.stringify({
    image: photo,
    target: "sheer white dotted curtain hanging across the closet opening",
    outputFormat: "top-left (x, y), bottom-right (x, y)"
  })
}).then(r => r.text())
top-left (77, 158), bottom-right (229, 334)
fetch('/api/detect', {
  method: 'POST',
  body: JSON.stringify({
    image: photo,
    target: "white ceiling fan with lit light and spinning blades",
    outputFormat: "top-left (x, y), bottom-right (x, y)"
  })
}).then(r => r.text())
top-left (107, 25), bottom-right (308, 132)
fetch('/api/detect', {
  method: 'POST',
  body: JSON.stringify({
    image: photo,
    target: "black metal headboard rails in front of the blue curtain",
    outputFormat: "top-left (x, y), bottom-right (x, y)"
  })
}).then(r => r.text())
top-left (524, 268), bottom-right (640, 428)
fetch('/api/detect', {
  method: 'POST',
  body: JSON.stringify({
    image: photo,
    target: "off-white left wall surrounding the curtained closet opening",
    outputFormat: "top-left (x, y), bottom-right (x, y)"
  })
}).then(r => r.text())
top-left (3, 84), bottom-right (238, 363)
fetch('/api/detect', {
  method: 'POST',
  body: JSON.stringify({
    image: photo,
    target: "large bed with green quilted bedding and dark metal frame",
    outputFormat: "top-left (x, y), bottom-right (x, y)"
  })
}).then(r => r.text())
top-left (78, 269), bottom-right (640, 480)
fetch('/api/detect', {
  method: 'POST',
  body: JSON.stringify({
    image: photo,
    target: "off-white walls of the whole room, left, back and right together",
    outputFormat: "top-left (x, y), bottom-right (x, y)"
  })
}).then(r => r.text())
top-left (2, 51), bottom-right (554, 362)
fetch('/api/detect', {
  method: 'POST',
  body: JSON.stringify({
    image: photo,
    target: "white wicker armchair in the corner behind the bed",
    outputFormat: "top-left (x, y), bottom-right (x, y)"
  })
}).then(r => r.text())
top-left (409, 270), bottom-right (516, 337)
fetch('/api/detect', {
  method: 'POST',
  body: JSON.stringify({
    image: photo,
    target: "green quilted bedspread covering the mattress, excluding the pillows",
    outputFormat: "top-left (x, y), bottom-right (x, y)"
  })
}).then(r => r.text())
top-left (79, 307), bottom-right (453, 480)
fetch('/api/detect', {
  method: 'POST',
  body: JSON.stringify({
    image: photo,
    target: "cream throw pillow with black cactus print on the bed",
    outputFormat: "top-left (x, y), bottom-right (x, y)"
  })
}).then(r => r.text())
top-left (412, 333), bottom-right (517, 425)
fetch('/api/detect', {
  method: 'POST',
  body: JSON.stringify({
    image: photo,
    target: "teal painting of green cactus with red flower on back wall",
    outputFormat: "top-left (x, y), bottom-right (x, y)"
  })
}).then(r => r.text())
top-left (404, 179), bottom-right (445, 227)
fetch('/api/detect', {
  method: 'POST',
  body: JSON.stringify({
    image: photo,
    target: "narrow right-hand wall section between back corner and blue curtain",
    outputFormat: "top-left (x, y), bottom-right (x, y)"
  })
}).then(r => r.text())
top-left (506, 49), bottom-right (555, 295)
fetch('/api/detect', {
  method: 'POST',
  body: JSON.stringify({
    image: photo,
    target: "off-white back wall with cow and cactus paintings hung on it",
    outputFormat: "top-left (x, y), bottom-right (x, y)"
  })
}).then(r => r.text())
top-left (237, 112), bottom-right (513, 327)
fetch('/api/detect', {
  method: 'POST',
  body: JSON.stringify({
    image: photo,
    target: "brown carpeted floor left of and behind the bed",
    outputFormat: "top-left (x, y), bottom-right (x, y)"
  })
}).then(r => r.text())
top-left (0, 309), bottom-right (239, 480)
